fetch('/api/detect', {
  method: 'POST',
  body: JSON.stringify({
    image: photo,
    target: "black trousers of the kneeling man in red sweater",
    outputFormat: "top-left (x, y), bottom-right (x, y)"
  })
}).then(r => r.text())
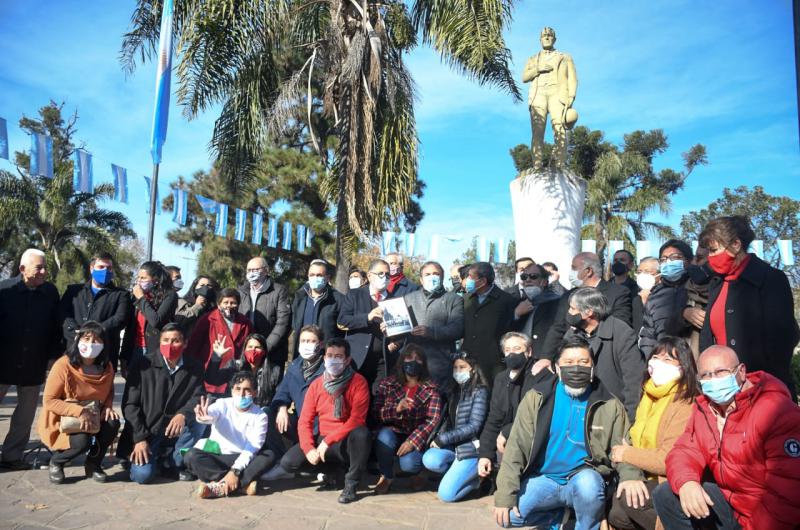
top-left (281, 425), bottom-right (372, 486)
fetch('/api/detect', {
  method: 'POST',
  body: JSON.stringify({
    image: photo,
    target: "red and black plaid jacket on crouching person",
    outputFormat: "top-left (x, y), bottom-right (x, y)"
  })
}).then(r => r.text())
top-left (373, 375), bottom-right (442, 451)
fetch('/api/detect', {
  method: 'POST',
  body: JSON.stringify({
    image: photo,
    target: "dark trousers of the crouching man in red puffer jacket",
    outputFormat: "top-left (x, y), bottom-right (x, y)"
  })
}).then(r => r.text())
top-left (653, 482), bottom-right (744, 530)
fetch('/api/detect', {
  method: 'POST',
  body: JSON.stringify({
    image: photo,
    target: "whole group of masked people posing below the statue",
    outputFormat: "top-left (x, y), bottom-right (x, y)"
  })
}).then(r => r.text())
top-left (0, 212), bottom-right (800, 530)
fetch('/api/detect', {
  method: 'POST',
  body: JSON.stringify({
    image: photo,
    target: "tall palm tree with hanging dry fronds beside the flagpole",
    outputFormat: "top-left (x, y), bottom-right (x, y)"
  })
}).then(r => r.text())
top-left (122, 0), bottom-right (520, 286)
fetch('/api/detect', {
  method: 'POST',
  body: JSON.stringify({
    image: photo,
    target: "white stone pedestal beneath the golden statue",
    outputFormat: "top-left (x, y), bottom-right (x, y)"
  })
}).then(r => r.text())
top-left (509, 169), bottom-right (586, 280)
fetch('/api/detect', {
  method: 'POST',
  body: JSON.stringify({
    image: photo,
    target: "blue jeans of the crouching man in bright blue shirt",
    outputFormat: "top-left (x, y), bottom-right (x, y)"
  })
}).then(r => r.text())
top-left (511, 469), bottom-right (606, 530)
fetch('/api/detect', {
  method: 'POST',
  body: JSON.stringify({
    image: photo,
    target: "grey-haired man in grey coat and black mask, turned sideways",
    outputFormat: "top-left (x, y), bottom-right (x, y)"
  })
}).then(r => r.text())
top-left (564, 287), bottom-right (646, 420)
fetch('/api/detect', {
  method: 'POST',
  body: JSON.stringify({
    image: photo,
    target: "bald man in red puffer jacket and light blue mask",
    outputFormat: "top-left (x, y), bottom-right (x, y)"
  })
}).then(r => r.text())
top-left (653, 345), bottom-right (800, 530)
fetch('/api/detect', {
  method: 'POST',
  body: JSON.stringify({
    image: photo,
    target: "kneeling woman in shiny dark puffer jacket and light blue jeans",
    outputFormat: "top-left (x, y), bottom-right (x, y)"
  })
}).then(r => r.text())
top-left (422, 352), bottom-right (489, 502)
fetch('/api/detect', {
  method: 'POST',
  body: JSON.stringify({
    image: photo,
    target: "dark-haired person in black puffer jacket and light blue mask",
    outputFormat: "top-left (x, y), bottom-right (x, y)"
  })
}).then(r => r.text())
top-left (639, 239), bottom-right (694, 359)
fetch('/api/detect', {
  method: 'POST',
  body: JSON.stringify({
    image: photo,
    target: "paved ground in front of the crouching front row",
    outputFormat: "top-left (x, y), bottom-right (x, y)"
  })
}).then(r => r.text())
top-left (0, 381), bottom-right (496, 530)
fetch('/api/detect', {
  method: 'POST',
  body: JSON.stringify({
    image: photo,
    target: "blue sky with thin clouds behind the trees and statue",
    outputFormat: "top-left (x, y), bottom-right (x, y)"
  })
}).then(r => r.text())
top-left (0, 0), bottom-right (800, 276)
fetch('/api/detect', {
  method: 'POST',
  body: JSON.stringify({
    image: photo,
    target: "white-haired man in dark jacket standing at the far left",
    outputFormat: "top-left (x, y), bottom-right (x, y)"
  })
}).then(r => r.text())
top-left (0, 248), bottom-right (63, 470)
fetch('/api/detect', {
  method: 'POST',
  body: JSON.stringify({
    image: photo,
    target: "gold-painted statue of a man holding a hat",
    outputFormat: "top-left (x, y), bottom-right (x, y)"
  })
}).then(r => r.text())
top-left (522, 27), bottom-right (578, 170)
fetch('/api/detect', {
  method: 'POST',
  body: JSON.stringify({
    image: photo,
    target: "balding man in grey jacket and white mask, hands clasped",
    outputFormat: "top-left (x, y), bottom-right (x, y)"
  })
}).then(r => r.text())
top-left (239, 257), bottom-right (292, 381)
